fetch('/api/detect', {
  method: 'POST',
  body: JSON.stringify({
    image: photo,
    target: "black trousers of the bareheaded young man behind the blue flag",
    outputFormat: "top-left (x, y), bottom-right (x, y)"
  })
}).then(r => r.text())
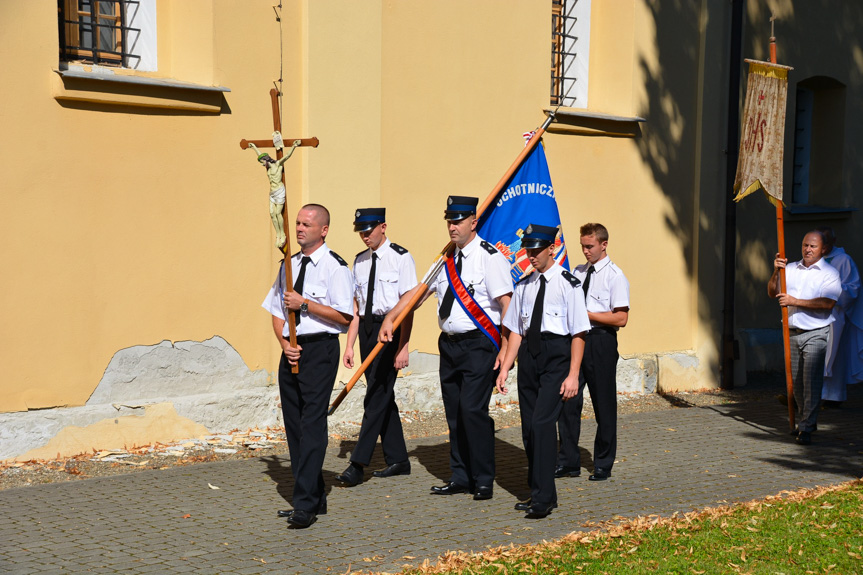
top-left (557, 328), bottom-right (620, 470)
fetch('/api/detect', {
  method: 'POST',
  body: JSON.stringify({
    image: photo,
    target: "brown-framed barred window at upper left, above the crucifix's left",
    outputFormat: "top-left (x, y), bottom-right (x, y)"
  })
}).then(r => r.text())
top-left (57, 0), bottom-right (141, 68)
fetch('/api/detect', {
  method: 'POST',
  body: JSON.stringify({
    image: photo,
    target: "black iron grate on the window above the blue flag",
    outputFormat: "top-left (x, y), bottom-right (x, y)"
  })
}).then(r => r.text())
top-left (551, 0), bottom-right (578, 107)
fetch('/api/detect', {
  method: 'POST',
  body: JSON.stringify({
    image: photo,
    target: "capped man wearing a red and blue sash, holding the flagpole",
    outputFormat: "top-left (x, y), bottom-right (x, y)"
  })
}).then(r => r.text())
top-left (379, 196), bottom-right (512, 500)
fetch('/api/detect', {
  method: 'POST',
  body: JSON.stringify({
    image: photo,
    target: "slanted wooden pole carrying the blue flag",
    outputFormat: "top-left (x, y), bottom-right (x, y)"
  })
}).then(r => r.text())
top-left (327, 112), bottom-right (554, 415)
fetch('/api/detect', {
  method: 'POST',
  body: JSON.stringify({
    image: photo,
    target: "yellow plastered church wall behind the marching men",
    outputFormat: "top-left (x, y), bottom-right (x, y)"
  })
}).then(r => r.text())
top-left (5, 0), bottom-right (804, 428)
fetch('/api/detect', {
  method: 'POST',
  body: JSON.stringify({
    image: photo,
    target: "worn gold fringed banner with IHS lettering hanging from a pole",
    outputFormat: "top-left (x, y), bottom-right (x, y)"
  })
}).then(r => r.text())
top-left (734, 60), bottom-right (793, 204)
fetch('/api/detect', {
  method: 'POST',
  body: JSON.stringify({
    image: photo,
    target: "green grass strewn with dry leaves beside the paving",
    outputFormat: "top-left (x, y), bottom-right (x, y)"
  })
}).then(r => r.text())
top-left (405, 481), bottom-right (863, 575)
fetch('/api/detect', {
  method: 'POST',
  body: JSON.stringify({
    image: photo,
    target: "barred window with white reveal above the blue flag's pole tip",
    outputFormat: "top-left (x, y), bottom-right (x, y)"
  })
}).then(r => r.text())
top-left (551, 0), bottom-right (590, 108)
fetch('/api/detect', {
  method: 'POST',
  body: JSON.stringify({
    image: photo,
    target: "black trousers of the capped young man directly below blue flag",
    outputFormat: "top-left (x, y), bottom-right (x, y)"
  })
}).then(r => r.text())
top-left (518, 337), bottom-right (574, 505)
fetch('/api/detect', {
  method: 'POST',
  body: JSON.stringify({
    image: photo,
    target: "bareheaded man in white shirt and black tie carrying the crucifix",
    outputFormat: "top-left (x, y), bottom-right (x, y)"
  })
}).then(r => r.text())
top-left (261, 204), bottom-right (354, 528)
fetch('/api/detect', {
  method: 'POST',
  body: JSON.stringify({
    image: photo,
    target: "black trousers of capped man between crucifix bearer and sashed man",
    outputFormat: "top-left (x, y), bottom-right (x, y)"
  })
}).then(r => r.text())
top-left (351, 321), bottom-right (408, 465)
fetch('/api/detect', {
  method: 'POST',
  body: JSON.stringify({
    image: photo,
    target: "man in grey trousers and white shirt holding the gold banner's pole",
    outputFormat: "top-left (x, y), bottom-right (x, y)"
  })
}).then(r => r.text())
top-left (767, 230), bottom-right (842, 445)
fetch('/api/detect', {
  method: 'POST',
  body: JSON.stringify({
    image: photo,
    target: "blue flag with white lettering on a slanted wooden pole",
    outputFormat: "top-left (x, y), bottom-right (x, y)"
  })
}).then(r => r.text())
top-left (477, 142), bottom-right (569, 285)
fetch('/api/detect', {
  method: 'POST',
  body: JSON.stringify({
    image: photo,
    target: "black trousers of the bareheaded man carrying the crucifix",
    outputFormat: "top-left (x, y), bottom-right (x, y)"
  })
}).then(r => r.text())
top-left (279, 338), bottom-right (339, 512)
